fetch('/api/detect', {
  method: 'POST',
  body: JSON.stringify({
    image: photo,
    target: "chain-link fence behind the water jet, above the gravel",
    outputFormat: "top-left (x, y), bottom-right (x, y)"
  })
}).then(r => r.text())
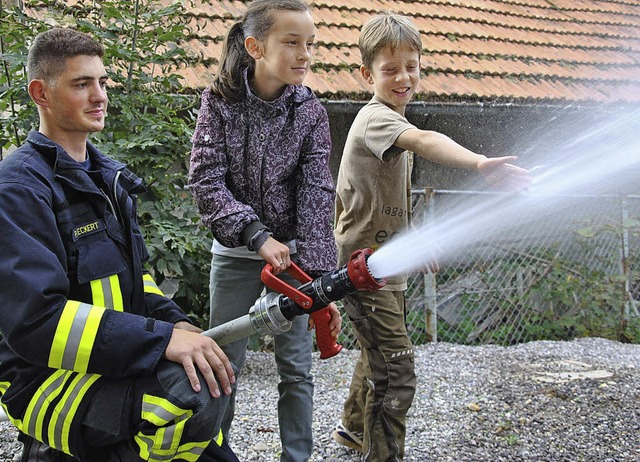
top-left (340, 190), bottom-right (640, 348)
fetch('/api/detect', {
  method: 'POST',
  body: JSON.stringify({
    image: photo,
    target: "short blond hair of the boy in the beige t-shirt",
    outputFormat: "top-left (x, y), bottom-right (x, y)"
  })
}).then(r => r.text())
top-left (358, 11), bottom-right (422, 68)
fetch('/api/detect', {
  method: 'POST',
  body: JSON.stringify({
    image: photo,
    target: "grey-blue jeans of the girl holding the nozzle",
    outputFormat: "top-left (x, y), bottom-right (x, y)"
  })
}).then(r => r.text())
top-left (209, 255), bottom-right (313, 462)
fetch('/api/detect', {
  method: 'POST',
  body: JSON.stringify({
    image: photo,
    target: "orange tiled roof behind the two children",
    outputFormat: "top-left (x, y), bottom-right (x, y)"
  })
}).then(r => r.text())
top-left (23, 0), bottom-right (640, 104)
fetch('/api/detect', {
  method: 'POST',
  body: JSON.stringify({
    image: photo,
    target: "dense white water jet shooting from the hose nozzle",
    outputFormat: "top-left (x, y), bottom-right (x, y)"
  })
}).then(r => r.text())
top-left (368, 111), bottom-right (640, 277)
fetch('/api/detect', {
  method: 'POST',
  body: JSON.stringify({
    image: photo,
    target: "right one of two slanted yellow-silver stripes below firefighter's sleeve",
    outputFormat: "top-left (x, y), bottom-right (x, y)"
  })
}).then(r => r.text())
top-left (48, 374), bottom-right (100, 454)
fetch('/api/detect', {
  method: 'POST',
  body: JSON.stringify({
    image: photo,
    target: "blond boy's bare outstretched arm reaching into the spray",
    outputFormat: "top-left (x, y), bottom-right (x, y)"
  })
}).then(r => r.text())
top-left (394, 128), bottom-right (531, 191)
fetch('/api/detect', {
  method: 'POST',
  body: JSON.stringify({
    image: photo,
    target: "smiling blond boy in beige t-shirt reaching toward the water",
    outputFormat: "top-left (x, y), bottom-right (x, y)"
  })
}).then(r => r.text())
top-left (333, 13), bottom-right (528, 462)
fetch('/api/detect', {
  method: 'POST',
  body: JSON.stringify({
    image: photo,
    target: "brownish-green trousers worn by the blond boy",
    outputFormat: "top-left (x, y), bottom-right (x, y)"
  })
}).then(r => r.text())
top-left (342, 290), bottom-right (416, 462)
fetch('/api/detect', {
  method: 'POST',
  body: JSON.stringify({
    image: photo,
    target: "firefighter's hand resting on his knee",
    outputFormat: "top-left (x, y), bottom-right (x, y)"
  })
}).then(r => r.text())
top-left (164, 322), bottom-right (236, 398)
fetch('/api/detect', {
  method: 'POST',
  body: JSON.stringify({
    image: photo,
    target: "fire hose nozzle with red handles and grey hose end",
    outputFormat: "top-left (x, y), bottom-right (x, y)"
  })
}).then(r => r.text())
top-left (203, 249), bottom-right (386, 359)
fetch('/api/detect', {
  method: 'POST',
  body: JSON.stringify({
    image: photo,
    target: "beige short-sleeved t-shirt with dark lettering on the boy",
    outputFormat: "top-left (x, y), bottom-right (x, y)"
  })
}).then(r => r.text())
top-left (335, 96), bottom-right (416, 290)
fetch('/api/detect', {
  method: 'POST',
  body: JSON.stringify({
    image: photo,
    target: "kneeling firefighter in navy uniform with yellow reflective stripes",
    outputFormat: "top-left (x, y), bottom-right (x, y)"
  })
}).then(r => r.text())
top-left (0, 28), bottom-right (237, 462)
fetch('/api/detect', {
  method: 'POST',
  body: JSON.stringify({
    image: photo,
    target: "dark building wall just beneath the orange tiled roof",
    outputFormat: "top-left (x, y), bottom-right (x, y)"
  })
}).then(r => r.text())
top-left (325, 101), bottom-right (637, 190)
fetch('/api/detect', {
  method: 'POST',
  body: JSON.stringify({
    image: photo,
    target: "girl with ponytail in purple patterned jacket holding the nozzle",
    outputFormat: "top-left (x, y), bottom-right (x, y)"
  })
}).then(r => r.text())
top-left (189, 0), bottom-right (341, 462)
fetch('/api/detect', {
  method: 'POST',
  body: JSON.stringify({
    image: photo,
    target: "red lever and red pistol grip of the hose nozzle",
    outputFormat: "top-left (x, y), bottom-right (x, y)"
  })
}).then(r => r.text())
top-left (260, 262), bottom-right (342, 359)
